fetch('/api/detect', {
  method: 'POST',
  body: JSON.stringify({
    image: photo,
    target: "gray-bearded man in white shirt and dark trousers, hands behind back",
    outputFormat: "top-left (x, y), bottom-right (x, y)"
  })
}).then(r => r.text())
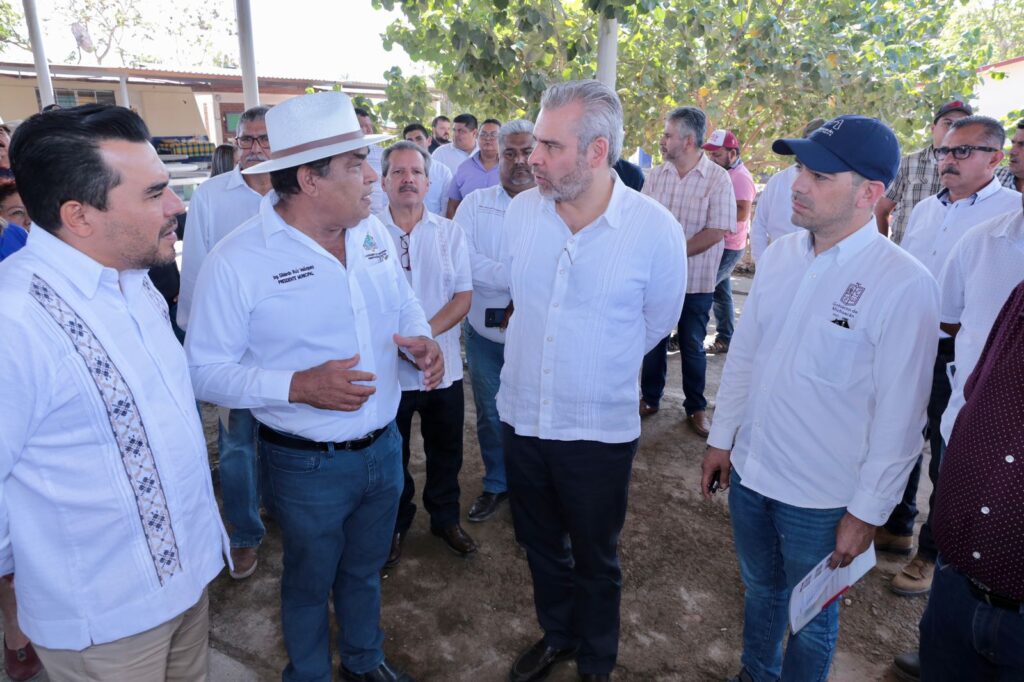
top-left (498, 81), bottom-right (684, 682)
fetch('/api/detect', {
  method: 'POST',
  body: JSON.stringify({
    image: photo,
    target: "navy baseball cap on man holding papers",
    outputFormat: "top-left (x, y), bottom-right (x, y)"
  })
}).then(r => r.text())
top-left (771, 114), bottom-right (900, 186)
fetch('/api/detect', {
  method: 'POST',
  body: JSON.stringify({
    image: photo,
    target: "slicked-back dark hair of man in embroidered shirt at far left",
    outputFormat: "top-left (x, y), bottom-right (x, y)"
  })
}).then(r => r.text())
top-left (10, 104), bottom-right (150, 232)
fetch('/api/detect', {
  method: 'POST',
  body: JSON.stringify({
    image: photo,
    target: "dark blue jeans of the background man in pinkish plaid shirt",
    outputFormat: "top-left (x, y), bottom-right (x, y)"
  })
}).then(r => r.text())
top-left (640, 294), bottom-right (714, 415)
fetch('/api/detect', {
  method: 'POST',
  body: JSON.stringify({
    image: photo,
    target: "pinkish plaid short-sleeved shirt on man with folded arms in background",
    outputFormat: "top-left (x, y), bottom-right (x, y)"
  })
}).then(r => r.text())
top-left (643, 154), bottom-right (736, 294)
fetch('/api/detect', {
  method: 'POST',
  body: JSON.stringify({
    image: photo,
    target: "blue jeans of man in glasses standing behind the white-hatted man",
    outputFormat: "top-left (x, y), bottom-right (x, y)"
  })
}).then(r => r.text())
top-left (217, 403), bottom-right (269, 547)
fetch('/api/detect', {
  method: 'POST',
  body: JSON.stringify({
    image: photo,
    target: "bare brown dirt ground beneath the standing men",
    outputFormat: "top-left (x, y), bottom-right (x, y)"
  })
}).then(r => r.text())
top-left (199, 278), bottom-right (928, 682)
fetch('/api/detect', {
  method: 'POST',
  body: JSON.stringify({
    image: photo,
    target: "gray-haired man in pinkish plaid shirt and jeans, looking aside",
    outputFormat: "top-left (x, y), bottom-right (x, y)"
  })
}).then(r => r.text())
top-left (640, 106), bottom-right (736, 437)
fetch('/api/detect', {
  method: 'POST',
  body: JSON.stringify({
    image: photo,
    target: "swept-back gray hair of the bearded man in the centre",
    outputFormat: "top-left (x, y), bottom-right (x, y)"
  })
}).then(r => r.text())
top-left (541, 80), bottom-right (626, 166)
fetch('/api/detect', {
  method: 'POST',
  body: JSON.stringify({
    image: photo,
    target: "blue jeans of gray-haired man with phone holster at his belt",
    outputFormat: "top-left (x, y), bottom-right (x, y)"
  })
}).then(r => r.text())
top-left (463, 323), bottom-right (509, 494)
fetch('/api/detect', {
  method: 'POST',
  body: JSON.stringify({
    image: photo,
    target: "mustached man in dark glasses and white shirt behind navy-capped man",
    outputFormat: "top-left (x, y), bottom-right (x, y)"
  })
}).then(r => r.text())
top-left (874, 116), bottom-right (1021, 597)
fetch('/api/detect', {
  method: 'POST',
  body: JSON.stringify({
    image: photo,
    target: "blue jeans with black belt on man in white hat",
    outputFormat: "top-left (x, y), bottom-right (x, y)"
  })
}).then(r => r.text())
top-left (260, 422), bottom-right (402, 682)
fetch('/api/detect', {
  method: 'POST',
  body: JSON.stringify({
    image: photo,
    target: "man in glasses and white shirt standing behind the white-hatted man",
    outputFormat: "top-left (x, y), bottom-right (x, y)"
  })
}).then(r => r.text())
top-left (177, 106), bottom-right (270, 580)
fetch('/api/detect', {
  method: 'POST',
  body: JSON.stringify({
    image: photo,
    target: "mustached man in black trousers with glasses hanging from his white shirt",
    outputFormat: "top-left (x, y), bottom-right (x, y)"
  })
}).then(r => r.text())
top-left (377, 140), bottom-right (476, 567)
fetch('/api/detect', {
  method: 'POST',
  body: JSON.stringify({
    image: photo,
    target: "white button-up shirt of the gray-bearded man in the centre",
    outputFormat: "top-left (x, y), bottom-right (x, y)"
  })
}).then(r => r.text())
top-left (498, 171), bottom-right (686, 442)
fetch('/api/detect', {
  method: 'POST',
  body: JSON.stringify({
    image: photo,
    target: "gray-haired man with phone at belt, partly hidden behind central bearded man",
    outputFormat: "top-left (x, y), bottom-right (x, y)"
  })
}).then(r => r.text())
top-left (455, 119), bottom-right (537, 523)
